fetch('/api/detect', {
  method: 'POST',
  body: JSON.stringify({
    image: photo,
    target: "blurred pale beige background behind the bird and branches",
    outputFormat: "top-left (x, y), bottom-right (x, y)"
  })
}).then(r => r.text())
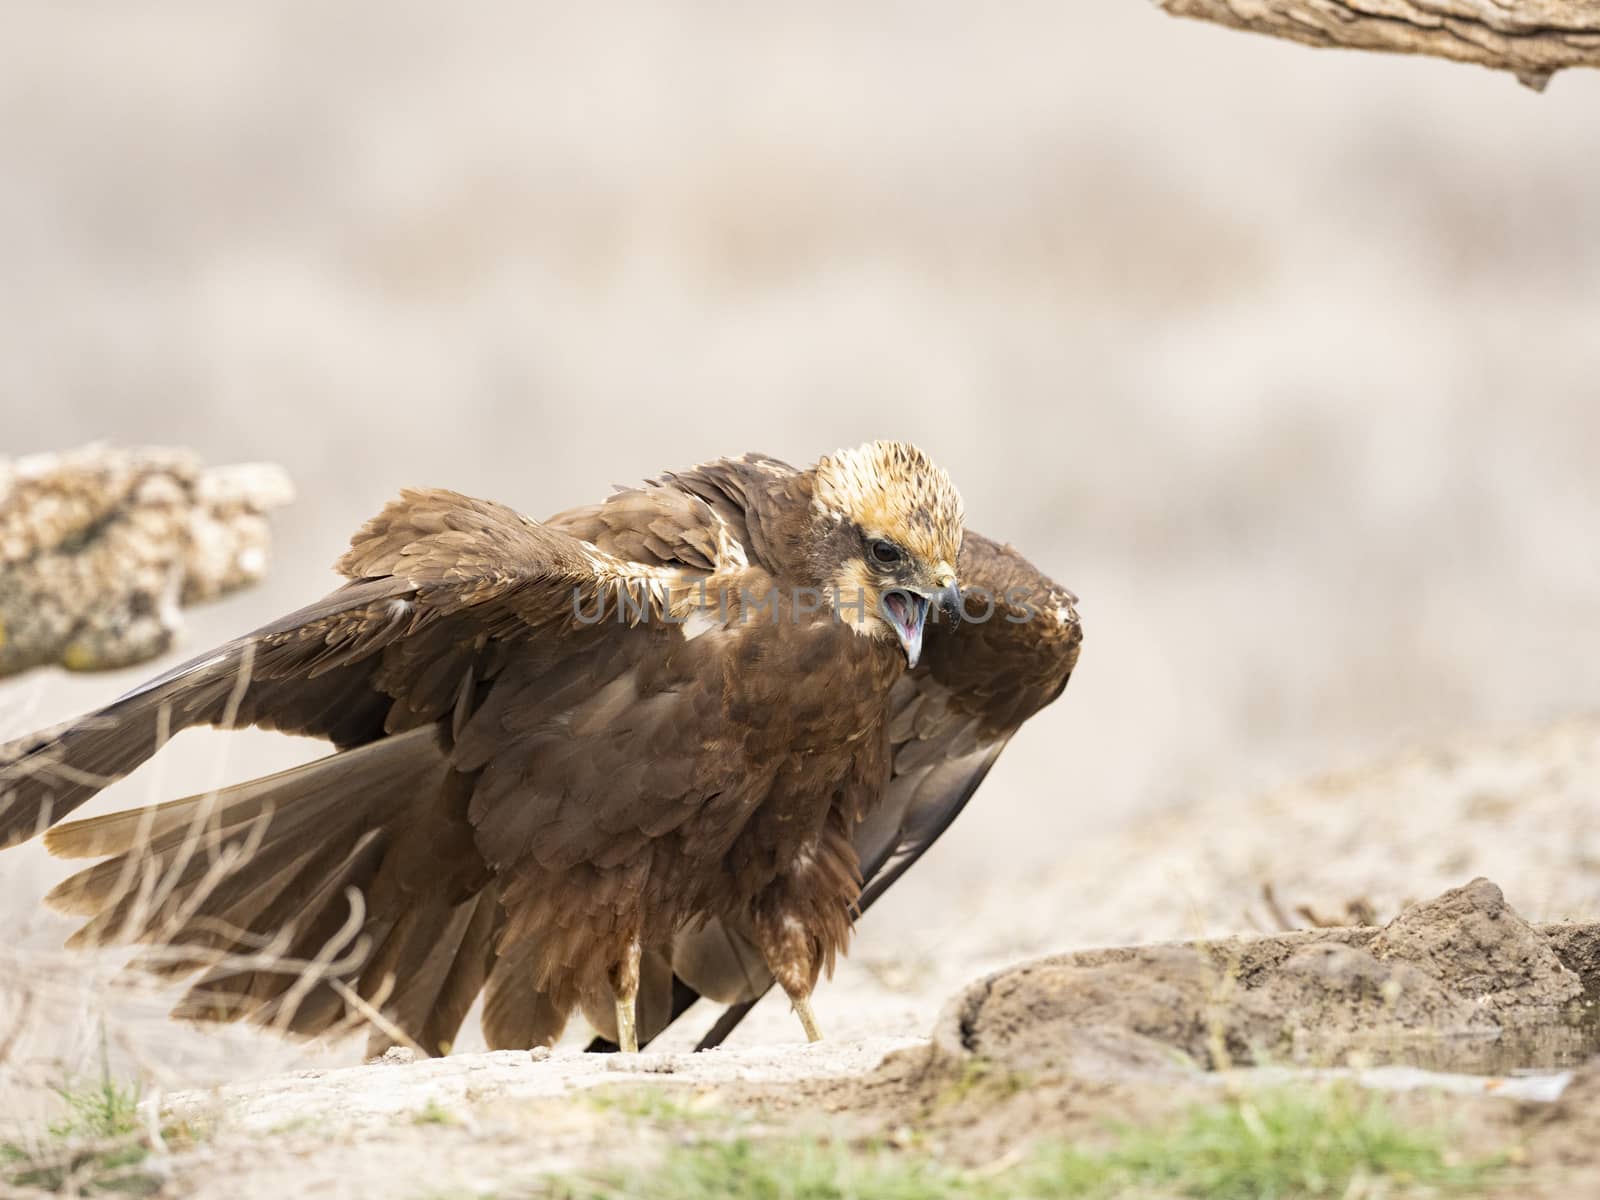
top-left (0, 0), bottom-right (1600, 1081)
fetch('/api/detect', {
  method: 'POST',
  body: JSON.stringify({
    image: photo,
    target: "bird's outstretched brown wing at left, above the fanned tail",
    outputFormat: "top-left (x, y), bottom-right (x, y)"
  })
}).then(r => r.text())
top-left (0, 491), bottom-right (688, 848)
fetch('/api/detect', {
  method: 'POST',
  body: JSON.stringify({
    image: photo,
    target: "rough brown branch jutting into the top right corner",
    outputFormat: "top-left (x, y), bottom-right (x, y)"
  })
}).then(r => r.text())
top-left (1155, 0), bottom-right (1600, 91)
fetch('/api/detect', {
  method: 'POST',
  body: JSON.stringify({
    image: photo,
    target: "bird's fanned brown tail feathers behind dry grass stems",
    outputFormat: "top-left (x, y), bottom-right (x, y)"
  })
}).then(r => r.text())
top-left (36, 726), bottom-right (499, 1053)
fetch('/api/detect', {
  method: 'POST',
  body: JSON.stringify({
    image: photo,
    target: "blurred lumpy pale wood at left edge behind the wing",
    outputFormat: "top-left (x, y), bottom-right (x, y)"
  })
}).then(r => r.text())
top-left (0, 446), bottom-right (293, 675)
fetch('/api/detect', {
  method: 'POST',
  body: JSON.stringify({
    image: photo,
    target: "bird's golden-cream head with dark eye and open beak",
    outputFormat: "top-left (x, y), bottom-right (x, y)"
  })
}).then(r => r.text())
top-left (811, 442), bottom-right (963, 667)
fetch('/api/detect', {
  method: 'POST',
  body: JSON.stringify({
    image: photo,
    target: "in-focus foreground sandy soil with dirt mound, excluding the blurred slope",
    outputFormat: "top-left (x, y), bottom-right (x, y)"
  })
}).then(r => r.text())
top-left (56, 880), bottom-right (1600, 1197)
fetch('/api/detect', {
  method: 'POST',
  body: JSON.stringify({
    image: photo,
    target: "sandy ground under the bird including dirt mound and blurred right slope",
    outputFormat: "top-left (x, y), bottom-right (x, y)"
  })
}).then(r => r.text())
top-left (9, 722), bottom-right (1600, 1197)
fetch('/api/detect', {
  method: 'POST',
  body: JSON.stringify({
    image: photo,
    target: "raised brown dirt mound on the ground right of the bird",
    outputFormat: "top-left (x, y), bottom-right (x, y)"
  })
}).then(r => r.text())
top-left (934, 878), bottom-right (1587, 1077)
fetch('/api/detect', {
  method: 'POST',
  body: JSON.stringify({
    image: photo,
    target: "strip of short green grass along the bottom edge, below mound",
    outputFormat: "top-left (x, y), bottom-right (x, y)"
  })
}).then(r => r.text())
top-left (542, 1088), bottom-right (1501, 1200)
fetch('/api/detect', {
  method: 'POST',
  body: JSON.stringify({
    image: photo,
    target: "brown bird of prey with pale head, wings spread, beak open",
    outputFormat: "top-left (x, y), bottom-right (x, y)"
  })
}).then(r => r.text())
top-left (0, 442), bottom-right (1080, 1053)
